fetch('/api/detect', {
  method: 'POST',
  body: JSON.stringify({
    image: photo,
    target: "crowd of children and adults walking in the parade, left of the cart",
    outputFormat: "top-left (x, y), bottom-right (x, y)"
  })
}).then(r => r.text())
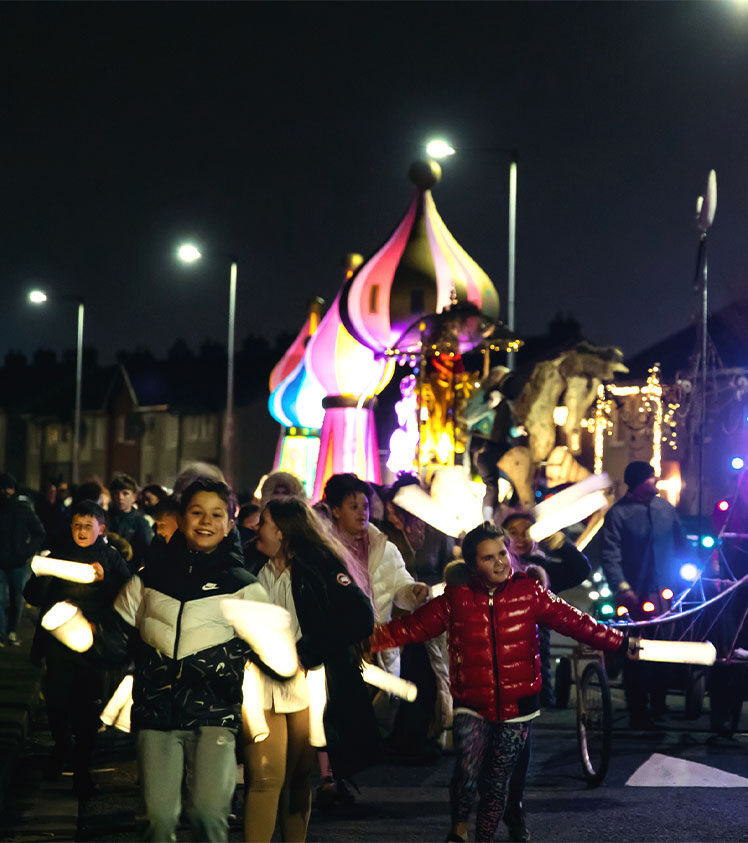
top-left (0, 464), bottom-right (712, 841)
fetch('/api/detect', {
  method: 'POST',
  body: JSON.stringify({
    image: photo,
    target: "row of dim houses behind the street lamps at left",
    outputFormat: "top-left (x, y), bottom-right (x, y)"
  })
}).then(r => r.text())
top-left (0, 352), bottom-right (278, 492)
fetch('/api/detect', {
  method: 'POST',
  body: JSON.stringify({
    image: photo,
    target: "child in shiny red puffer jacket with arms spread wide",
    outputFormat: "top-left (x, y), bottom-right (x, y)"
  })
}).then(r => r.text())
top-left (371, 522), bottom-right (625, 841)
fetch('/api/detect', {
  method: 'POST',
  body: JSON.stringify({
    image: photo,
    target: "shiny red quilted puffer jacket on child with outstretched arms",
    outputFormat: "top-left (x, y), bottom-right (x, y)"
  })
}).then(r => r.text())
top-left (371, 573), bottom-right (623, 720)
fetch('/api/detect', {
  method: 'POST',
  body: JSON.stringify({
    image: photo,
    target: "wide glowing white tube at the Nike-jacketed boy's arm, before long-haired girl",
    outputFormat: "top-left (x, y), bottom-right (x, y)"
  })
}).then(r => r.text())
top-left (221, 598), bottom-right (299, 679)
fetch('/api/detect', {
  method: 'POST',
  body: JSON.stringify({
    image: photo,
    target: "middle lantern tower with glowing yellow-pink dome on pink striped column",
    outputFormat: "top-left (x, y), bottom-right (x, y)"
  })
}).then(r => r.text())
top-left (304, 254), bottom-right (395, 500)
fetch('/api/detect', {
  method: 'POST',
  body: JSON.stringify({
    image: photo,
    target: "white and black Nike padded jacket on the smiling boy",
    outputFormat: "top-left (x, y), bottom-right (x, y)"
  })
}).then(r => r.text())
top-left (96, 532), bottom-right (268, 730)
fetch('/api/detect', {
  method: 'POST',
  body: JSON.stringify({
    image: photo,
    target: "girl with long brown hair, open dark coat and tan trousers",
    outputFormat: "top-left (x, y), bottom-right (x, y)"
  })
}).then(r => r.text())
top-left (245, 498), bottom-right (380, 841)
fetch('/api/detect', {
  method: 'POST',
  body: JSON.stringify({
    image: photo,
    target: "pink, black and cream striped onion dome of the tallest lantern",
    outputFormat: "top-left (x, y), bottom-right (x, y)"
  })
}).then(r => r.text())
top-left (342, 161), bottom-right (499, 354)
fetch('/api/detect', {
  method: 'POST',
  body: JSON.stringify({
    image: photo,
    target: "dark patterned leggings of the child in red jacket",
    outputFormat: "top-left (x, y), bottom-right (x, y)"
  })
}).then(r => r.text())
top-left (449, 712), bottom-right (529, 841)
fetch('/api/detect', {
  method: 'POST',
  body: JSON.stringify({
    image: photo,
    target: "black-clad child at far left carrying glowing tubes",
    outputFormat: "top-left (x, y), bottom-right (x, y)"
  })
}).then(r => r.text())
top-left (24, 500), bottom-right (130, 798)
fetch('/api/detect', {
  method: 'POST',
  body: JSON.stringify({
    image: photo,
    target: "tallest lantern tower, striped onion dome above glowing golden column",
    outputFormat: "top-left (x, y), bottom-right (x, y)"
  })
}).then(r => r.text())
top-left (340, 161), bottom-right (508, 475)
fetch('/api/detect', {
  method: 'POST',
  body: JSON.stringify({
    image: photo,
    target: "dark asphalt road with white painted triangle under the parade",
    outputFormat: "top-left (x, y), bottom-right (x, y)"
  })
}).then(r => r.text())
top-left (0, 691), bottom-right (748, 843)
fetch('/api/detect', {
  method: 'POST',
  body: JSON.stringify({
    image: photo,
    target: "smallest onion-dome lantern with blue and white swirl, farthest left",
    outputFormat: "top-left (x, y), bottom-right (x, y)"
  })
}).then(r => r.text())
top-left (268, 298), bottom-right (325, 495)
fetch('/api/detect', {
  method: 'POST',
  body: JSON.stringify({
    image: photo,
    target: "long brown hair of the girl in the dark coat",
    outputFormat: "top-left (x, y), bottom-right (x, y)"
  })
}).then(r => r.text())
top-left (265, 498), bottom-right (347, 568)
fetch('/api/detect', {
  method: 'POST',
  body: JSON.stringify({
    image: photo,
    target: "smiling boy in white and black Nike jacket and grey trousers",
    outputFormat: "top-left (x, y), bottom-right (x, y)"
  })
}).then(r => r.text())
top-left (89, 478), bottom-right (267, 841)
